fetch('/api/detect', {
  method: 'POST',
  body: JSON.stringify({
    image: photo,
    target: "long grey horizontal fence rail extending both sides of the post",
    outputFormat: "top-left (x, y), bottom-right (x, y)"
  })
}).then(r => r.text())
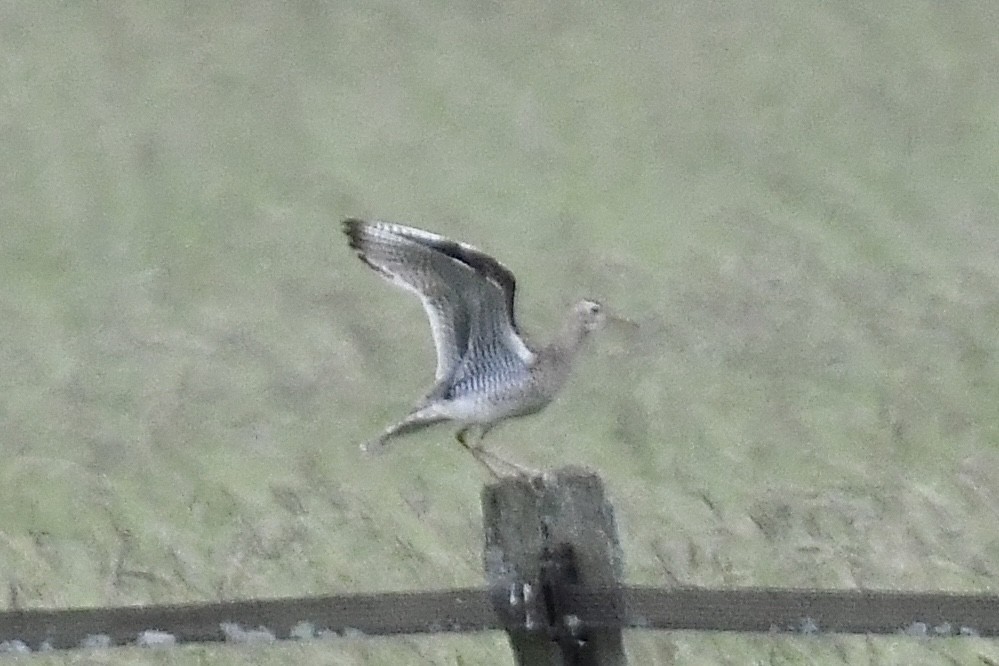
top-left (0, 586), bottom-right (999, 650)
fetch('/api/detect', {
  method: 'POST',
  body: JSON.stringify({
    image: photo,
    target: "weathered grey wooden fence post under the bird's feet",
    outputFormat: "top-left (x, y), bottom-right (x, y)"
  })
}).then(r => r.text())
top-left (482, 467), bottom-right (627, 666)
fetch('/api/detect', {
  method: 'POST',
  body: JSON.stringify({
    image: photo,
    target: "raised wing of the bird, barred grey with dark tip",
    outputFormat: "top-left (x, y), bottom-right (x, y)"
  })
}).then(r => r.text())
top-left (343, 219), bottom-right (534, 382)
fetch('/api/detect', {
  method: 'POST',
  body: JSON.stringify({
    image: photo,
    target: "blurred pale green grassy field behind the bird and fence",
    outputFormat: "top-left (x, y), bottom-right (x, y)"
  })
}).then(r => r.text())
top-left (0, 0), bottom-right (999, 665)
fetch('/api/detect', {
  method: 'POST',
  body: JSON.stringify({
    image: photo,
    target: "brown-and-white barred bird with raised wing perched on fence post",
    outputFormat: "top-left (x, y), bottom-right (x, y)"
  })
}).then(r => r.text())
top-left (343, 218), bottom-right (608, 478)
